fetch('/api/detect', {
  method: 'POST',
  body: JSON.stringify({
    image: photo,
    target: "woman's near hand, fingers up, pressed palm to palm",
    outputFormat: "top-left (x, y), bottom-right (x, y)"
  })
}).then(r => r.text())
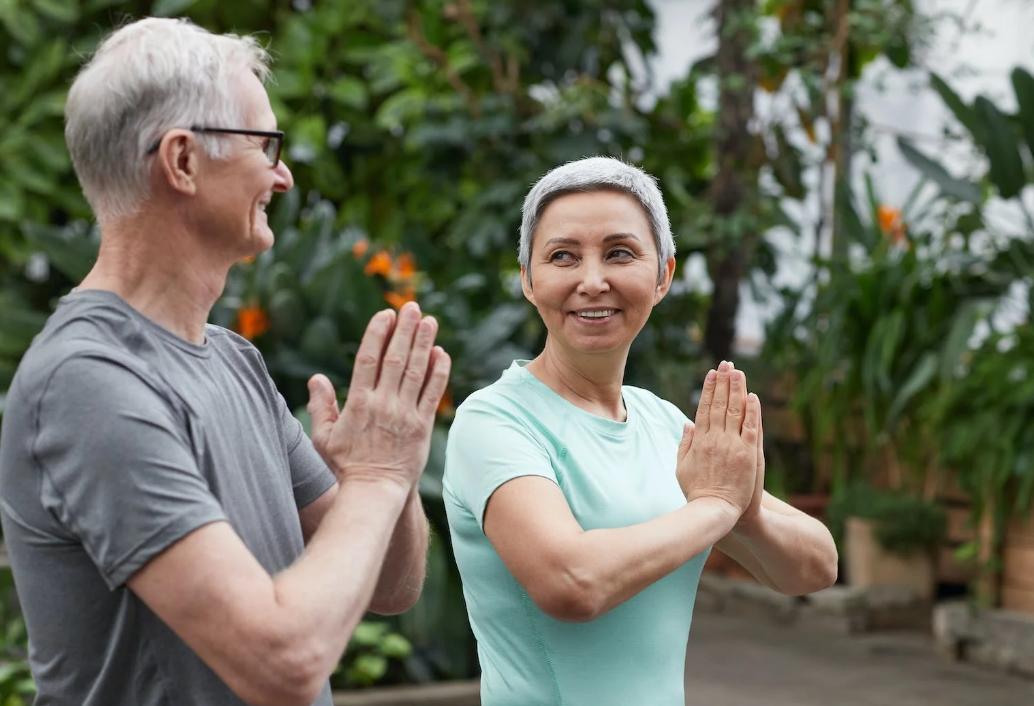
top-left (676, 362), bottom-right (761, 517)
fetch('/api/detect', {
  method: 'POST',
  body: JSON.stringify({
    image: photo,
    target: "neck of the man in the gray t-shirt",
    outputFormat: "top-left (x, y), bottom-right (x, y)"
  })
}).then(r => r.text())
top-left (79, 214), bottom-right (230, 344)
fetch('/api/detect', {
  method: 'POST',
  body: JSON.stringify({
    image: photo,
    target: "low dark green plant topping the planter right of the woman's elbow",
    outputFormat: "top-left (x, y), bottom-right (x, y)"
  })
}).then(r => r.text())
top-left (827, 483), bottom-right (947, 556)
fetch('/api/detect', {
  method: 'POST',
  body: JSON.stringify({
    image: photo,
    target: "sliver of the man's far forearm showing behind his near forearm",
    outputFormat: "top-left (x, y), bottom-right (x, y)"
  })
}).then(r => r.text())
top-left (370, 487), bottom-right (428, 615)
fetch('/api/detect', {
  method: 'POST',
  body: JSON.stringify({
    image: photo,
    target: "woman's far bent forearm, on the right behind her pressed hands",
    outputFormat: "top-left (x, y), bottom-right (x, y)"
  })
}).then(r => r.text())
top-left (719, 507), bottom-right (838, 595)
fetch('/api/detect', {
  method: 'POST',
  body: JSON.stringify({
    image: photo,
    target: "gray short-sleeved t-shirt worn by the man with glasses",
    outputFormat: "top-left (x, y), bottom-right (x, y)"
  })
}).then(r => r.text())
top-left (0, 290), bottom-right (334, 706)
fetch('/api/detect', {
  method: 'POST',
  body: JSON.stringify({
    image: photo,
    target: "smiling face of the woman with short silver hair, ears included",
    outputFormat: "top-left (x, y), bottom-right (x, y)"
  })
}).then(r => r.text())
top-left (521, 191), bottom-right (675, 354)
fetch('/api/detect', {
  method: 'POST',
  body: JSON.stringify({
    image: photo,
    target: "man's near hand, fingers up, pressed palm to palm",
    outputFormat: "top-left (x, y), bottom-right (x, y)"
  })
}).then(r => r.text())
top-left (308, 303), bottom-right (451, 488)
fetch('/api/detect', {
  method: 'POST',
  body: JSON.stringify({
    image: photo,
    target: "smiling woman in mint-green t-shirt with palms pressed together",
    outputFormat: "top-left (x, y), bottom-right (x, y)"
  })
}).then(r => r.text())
top-left (445, 157), bottom-right (837, 706)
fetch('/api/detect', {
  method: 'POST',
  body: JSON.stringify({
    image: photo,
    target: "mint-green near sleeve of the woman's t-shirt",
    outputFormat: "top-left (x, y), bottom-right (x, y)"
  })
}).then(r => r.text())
top-left (446, 400), bottom-right (557, 530)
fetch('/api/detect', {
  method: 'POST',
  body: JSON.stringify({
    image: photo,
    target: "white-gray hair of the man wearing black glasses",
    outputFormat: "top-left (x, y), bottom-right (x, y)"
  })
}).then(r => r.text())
top-left (65, 18), bottom-right (269, 221)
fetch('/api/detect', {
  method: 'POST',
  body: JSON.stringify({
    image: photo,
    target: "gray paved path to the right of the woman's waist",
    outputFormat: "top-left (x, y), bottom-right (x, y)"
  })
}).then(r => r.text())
top-left (686, 611), bottom-right (1034, 706)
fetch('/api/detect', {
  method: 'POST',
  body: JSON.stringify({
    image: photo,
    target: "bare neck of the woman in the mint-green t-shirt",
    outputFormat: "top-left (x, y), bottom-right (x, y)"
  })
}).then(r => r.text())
top-left (527, 338), bottom-right (628, 422)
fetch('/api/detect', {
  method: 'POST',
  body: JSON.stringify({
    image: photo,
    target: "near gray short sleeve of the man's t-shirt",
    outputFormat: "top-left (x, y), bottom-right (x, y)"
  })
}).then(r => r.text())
top-left (32, 356), bottom-right (225, 589)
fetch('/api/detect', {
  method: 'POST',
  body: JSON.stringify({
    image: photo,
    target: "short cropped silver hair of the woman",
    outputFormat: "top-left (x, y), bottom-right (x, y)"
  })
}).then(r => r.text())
top-left (517, 157), bottom-right (675, 281)
